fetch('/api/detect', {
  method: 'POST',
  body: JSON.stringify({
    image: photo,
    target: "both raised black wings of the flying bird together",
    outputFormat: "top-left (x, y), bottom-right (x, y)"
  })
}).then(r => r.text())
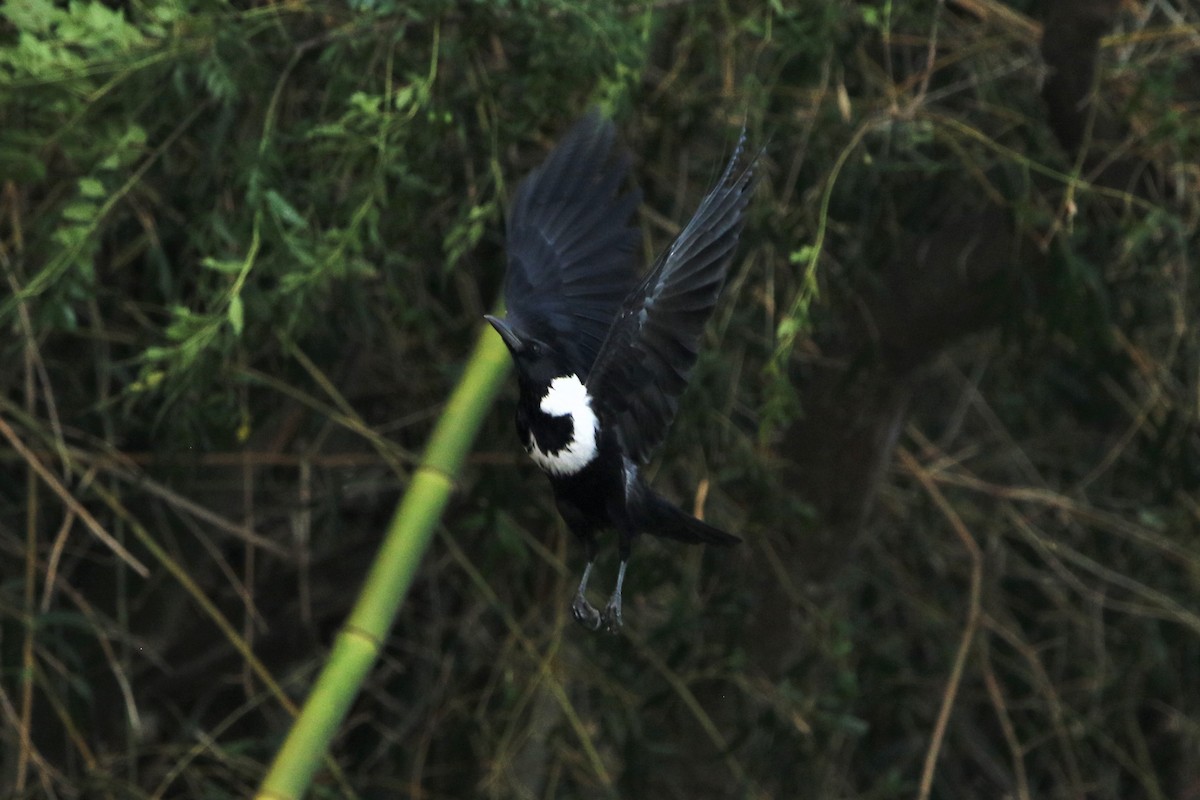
top-left (504, 112), bottom-right (756, 462)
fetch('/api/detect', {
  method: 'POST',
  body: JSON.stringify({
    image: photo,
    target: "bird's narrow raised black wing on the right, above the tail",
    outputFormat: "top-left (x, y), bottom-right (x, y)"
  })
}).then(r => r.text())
top-left (587, 132), bottom-right (757, 462)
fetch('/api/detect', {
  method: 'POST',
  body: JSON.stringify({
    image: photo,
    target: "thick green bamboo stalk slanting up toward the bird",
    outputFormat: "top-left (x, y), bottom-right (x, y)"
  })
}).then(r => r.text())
top-left (257, 326), bottom-right (511, 800)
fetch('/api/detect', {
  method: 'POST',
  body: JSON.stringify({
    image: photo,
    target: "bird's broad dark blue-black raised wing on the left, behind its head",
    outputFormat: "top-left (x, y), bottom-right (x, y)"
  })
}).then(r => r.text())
top-left (504, 110), bottom-right (641, 379)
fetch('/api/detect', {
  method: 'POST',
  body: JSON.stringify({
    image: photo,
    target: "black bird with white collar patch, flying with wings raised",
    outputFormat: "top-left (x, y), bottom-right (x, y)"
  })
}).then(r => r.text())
top-left (485, 109), bottom-right (757, 633)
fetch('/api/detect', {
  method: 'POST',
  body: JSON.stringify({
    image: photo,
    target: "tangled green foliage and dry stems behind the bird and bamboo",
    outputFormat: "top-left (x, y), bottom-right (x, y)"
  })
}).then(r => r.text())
top-left (0, 0), bottom-right (1200, 800)
